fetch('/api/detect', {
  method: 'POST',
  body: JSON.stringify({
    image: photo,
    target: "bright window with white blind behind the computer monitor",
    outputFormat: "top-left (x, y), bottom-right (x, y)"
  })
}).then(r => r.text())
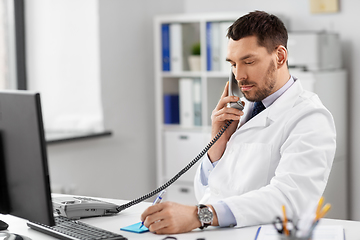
top-left (0, 0), bottom-right (109, 142)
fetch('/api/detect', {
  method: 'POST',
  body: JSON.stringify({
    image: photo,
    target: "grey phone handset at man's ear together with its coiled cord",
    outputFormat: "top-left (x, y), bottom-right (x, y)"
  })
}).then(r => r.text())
top-left (117, 72), bottom-right (244, 212)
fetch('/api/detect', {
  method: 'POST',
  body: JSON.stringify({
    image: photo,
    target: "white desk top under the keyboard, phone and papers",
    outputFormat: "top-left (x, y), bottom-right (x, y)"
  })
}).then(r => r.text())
top-left (0, 194), bottom-right (360, 240)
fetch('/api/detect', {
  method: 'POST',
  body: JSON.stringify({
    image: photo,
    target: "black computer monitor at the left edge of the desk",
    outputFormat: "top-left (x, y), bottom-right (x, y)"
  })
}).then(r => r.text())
top-left (0, 90), bottom-right (55, 226)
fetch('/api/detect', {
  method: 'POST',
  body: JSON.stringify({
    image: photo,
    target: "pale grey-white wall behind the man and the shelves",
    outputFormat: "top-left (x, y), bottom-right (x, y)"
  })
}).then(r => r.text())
top-left (27, 0), bottom-right (360, 220)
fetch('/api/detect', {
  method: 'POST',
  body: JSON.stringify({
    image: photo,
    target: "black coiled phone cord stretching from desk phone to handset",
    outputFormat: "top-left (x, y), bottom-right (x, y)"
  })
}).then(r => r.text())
top-left (116, 120), bottom-right (233, 212)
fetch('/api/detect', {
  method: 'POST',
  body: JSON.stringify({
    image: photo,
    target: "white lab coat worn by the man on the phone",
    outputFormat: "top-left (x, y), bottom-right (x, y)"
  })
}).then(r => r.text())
top-left (194, 80), bottom-right (336, 227)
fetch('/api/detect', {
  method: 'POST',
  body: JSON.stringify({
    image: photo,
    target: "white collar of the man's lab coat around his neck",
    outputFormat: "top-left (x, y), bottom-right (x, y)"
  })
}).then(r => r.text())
top-left (239, 77), bottom-right (303, 130)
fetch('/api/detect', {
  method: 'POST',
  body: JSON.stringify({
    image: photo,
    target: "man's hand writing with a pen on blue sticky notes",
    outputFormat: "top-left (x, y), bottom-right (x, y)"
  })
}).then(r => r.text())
top-left (141, 202), bottom-right (217, 234)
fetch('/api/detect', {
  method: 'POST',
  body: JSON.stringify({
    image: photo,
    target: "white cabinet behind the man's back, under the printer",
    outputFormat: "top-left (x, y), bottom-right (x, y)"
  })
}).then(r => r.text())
top-left (290, 69), bottom-right (348, 219)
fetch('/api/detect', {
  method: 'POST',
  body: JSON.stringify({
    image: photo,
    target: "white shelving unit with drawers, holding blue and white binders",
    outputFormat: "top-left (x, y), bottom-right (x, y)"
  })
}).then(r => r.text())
top-left (154, 13), bottom-right (243, 204)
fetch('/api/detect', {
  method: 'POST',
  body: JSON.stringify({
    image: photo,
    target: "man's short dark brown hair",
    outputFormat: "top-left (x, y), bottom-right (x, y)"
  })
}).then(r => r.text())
top-left (227, 11), bottom-right (288, 53)
